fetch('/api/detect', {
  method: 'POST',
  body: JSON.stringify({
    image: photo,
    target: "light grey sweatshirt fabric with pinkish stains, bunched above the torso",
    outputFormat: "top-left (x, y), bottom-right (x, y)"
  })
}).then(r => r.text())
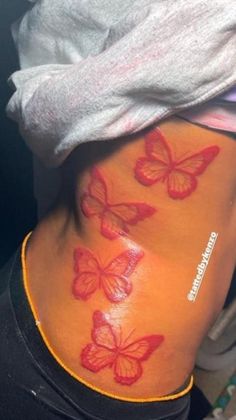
top-left (7, 0), bottom-right (236, 166)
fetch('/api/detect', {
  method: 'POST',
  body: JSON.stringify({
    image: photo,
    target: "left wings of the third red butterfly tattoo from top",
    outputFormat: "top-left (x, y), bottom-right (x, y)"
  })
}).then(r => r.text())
top-left (72, 247), bottom-right (99, 300)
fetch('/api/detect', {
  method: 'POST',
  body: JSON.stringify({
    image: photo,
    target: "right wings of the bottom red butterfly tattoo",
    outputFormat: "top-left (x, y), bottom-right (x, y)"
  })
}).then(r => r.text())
top-left (114, 335), bottom-right (164, 385)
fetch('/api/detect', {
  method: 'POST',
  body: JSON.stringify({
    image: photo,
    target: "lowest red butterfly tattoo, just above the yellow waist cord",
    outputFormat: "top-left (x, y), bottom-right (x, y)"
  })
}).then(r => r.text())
top-left (81, 311), bottom-right (164, 385)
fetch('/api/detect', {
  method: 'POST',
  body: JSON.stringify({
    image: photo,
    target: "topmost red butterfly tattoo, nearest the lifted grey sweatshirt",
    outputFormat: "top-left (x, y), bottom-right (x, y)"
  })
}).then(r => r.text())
top-left (135, 129), bottom-right (220, 199)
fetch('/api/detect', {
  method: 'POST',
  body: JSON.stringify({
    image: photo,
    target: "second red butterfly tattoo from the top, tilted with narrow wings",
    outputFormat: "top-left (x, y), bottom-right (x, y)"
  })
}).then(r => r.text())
top-left (81, 168), bottom-right (156, 239)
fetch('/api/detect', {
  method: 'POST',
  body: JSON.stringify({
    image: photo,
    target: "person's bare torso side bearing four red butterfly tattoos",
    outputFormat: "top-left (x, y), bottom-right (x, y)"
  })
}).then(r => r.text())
top-left (26, 120), bottom-right (236, 399)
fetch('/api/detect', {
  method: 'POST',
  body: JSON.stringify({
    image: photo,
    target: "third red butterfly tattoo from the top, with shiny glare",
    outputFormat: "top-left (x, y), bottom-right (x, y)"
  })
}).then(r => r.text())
top-left (73, 248), bottom-right (144, 302)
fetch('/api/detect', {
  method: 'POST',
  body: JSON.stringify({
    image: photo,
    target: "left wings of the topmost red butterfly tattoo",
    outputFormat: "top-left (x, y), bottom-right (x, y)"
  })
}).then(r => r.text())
top-left (134, 129), bottom-right (172, 186)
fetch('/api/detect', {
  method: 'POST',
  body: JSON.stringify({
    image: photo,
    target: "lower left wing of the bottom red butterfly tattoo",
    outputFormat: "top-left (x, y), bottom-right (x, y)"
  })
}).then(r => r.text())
top-left (81, 343), bottom-right (115, 372)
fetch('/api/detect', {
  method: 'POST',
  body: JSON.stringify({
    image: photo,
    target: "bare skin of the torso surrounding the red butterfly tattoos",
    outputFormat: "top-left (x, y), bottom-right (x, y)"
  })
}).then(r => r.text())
top-left (26, 118), bottom-right (236, 399)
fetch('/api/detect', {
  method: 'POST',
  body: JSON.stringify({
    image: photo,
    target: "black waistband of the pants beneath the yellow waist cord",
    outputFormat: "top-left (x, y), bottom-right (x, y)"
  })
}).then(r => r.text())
top-left (9, 249), bottom-right (189, 420)
